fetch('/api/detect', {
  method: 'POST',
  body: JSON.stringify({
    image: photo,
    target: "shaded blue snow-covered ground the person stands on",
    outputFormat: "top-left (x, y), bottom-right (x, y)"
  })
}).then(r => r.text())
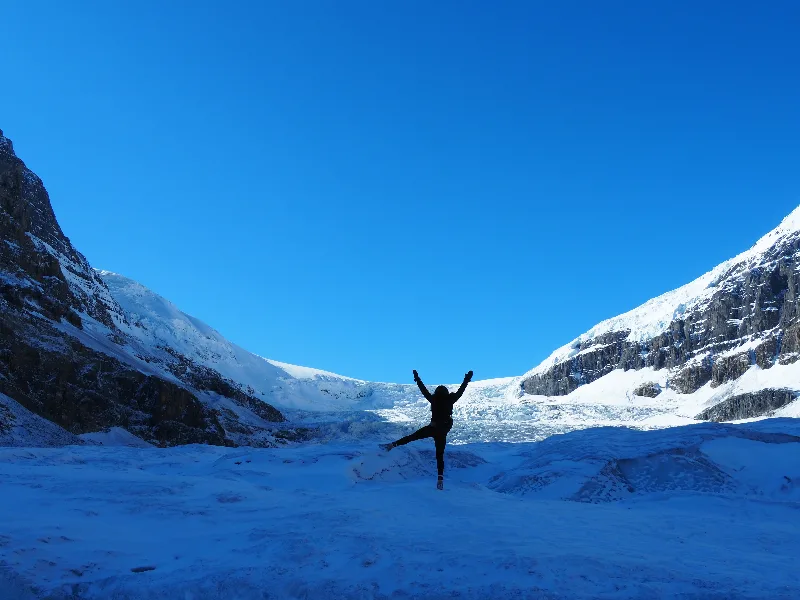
top-left (0, 419), bottom-right (800, 600)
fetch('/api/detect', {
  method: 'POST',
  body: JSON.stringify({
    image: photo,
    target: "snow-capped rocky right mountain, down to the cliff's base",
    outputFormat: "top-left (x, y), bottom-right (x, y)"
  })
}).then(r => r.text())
top-left (523, 207), bottom-right (800, 395)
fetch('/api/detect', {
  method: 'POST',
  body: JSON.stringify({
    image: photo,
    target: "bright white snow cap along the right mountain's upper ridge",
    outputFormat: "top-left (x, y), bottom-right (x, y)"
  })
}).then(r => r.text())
top-left (523, 207), bottom-right (800, 378)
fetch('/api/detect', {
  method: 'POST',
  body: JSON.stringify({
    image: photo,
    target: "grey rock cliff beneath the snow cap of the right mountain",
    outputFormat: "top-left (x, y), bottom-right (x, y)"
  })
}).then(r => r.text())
top-left (522, 220), bottom-right (800, 396)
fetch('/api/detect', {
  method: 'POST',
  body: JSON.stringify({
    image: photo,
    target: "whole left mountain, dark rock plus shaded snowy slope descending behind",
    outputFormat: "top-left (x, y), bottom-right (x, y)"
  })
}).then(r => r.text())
top-left (0, 125), bottom-right (404, 446)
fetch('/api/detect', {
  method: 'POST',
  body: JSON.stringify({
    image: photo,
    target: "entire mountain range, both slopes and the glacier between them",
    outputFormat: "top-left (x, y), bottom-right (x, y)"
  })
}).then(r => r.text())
top-left (0, 123), bottom-right (800, 445)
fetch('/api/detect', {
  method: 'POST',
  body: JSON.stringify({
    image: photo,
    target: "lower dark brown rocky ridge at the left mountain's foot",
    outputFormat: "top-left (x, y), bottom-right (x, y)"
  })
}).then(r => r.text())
top-left (0, 316), bottom-right (226, 445)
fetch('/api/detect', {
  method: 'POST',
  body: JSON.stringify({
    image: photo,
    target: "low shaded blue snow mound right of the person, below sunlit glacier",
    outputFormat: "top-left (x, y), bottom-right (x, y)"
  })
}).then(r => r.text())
top-left (490, 420), bottom-right (800, 503)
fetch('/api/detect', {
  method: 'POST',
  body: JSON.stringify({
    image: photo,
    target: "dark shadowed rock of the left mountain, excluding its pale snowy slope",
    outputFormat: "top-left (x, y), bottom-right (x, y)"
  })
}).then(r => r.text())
top-left (0, 131), bottom-right (285, 445)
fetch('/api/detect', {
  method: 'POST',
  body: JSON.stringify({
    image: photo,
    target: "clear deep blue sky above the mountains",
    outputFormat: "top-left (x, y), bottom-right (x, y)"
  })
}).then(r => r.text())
top-left (0, 0), bottom-right (800, 382)
